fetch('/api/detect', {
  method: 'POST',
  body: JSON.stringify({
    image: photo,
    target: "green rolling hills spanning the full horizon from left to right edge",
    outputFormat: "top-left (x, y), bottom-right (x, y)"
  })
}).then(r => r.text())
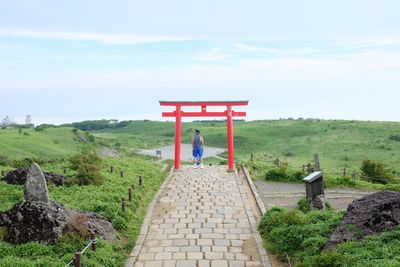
top-left (0, 119), bottom-right (400, 176)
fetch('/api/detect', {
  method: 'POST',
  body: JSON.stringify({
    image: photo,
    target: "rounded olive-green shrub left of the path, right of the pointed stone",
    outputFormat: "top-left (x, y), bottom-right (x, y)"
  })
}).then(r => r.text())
top-left (69, 150), bottom-right (104, 185)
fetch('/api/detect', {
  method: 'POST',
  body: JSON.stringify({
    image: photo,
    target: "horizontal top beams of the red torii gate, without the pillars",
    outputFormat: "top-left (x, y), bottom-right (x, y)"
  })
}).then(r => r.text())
top-left (160, 100), bottom-right (249, 117)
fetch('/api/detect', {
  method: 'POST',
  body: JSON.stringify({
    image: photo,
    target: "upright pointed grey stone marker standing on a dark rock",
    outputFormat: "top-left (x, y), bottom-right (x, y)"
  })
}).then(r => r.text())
top-left (24, 163), bottom-right (49, 203)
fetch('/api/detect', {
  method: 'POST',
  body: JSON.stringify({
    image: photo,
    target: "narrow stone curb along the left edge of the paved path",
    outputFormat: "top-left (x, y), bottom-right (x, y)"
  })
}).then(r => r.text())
top-left (125, 166), bottom-right (174, 267)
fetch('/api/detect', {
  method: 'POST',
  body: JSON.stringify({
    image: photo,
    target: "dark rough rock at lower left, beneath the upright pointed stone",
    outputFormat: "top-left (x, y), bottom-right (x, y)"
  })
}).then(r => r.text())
top-left (0, 201), bottom-right (116, 244)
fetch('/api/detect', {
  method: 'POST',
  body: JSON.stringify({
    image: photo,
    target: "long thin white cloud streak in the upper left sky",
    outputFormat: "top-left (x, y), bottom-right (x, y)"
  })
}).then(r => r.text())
top-left (0, 28), bottom-right (193, 45)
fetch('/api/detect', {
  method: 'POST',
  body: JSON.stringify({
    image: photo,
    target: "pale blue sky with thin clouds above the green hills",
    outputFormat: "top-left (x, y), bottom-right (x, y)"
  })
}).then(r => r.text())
top-left (0, 0), bottom-right (400, 124)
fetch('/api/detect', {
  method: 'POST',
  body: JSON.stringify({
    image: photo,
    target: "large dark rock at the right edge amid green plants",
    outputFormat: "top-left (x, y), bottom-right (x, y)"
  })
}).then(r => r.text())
top-left (325, 191), bottom-right (400, 249)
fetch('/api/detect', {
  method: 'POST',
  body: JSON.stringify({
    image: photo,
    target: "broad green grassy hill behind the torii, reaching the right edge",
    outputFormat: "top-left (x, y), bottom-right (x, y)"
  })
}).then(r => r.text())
top-left (94, 120), bottom-right (400, 178)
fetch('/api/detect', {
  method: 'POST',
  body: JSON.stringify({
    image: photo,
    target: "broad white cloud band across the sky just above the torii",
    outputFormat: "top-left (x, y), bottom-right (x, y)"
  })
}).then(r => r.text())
top-left (0, 48), bottom-right (400, 92)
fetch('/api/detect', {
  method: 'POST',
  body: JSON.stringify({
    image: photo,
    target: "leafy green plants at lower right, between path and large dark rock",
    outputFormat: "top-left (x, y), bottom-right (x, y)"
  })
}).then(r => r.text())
top-left (259, 208), bottom-right (400, 267)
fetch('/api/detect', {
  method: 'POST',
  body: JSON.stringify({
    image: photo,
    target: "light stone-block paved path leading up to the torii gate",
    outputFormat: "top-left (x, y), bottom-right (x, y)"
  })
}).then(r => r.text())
top-left (127, 166), bottom-right (270, 267)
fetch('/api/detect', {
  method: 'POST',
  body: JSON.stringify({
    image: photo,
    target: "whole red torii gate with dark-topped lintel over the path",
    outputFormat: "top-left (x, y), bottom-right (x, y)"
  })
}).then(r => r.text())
top-left (160, 100), bottom-right (249, 170)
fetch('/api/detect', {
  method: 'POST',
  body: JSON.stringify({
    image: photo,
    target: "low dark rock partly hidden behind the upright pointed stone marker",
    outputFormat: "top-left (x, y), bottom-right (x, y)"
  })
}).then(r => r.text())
top-left (2, 168), bottom-right (69, 186)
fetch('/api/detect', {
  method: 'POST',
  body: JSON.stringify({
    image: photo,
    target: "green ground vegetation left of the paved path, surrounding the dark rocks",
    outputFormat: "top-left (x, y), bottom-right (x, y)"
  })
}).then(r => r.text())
top-left (0, 157), bottom-right (166, 267)
